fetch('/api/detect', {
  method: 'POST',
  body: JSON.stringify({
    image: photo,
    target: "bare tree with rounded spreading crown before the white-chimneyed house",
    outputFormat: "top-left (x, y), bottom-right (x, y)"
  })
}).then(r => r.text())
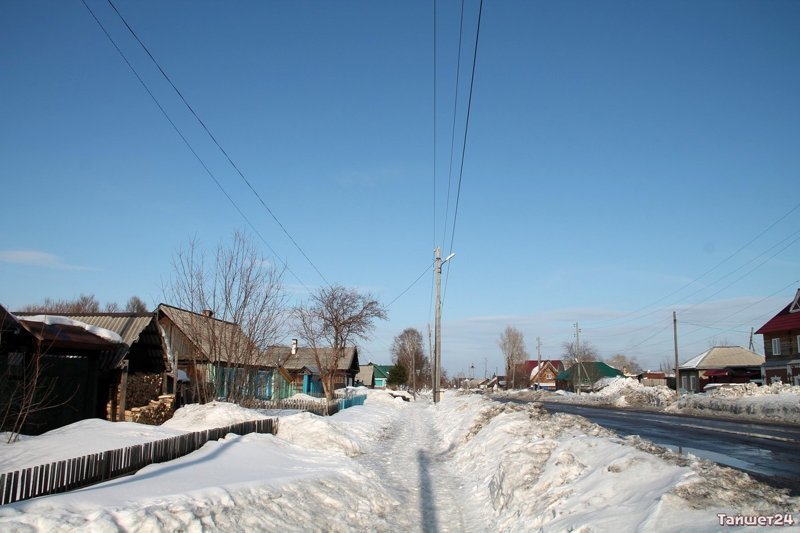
top-left (295, 285), bottom-right (386, 400)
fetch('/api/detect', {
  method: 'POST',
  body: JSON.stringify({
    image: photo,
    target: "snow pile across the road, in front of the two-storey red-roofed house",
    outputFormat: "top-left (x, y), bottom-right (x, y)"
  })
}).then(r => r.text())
top-left (666, 383), bottom-right (800, 424)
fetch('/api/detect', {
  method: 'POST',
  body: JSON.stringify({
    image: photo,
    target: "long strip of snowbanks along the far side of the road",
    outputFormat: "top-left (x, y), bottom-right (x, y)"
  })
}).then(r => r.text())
top-left (500, 378), bottom-right (800, 424)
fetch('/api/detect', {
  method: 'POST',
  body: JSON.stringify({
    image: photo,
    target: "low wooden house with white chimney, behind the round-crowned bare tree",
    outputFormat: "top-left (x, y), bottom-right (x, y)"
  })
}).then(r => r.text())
top-left (267, 341), bottom-right (361, 397)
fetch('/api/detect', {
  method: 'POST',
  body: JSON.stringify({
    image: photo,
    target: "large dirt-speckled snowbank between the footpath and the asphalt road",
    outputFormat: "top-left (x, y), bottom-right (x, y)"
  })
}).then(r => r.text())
top-left (436, 397), bottom-right (800, 532)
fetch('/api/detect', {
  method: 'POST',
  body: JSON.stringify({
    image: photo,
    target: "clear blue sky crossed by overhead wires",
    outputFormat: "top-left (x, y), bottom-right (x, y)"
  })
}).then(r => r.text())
top-left (0, 0), bottom-right (800, 375)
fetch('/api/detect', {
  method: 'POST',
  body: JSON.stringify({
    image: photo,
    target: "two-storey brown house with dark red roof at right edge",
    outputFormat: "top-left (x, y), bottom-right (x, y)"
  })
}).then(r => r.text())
top-left (756, 289), bottom-right (800, 385)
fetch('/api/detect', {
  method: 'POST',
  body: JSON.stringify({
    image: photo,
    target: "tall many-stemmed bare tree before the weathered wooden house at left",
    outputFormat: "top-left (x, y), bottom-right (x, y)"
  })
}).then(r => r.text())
top-left (165, 232), bottom-right (287, 402)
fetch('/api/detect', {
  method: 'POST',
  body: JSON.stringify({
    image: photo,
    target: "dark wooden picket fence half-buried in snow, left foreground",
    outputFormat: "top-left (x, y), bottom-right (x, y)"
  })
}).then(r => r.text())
top-left (0, 418), bottom-right (278, 505)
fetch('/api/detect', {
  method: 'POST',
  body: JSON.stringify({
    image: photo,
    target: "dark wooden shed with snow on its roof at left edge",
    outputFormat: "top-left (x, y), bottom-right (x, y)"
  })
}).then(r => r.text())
top-left (0, 306), bottom-right (128, 435)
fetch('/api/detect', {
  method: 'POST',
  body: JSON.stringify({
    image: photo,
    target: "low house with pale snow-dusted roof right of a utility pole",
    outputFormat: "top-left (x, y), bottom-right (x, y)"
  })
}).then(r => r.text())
top-left (678, 346), bottom-right (764, 392)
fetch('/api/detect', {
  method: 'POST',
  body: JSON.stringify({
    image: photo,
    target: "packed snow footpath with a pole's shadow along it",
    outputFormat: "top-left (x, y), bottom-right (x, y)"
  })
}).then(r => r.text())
top-left (357, 401), bottom-right (488, 533)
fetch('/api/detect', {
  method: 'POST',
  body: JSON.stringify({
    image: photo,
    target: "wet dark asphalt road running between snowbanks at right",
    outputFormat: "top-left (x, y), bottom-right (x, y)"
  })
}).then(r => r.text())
top-left (496, 398), bottom-right (800, 496)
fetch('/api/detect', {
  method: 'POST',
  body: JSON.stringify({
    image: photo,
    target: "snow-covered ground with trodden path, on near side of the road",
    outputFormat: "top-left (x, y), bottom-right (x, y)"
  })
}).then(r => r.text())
top-left (0, 391), bottom-right (800, 532)
